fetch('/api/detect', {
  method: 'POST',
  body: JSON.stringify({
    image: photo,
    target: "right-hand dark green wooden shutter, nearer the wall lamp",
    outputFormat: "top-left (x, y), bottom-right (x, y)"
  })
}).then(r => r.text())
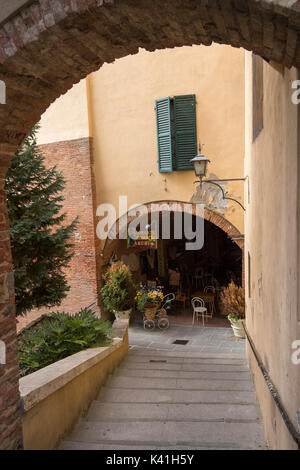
top-left (174, 95), bottom-right (197, 170)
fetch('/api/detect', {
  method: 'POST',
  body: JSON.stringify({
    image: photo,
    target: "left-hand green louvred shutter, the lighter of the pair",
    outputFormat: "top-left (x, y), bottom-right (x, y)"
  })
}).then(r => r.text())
top-left (155, 97), bottom-right (173, 173)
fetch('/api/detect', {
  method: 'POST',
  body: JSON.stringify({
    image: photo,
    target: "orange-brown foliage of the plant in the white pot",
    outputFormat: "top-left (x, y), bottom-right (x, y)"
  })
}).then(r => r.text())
top-left (220, 281), bottom-right (245, 320)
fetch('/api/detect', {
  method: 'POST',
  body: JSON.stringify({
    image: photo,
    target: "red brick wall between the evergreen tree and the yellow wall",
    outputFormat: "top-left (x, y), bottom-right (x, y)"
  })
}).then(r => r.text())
top-left (18, 138), bottom-right (97, 329)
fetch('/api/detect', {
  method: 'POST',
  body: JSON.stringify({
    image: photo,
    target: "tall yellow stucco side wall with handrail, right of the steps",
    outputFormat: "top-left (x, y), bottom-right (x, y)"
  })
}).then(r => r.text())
top-left (245, 53), bottom-right (300, 449)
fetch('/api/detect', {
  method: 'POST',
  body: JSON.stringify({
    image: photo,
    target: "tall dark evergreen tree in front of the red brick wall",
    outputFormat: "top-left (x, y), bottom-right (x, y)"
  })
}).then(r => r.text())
top-left (6, 126), bottom-right (78, 315)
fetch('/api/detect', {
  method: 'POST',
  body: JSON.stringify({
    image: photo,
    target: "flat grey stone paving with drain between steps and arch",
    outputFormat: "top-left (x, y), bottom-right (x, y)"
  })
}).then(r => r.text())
top-left (129, 324), bottom-right (245, 356)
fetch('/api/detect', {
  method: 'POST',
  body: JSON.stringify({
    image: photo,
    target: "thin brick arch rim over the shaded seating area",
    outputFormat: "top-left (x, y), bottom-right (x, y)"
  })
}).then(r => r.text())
top-left (101, 200), bottom-right (244, 265)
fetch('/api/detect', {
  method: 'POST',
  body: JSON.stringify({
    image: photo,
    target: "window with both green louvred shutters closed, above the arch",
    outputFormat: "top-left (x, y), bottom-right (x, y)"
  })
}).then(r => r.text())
top-left (156, 95), bottom-right (197, 172)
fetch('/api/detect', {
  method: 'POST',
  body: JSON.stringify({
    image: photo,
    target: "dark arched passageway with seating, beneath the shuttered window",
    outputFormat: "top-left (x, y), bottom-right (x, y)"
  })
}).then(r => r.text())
top-left (102, 201), bottom-right (243, 326)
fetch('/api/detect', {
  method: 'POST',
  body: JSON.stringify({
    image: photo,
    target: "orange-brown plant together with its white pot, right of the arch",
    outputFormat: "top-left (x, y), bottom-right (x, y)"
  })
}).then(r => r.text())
top-left (220, 281), bottom-right (245, 338)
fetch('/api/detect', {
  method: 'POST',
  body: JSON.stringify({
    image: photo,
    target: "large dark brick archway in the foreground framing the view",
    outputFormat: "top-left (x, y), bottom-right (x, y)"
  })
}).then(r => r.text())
top-left (0, 0), bottom-right (300, 449)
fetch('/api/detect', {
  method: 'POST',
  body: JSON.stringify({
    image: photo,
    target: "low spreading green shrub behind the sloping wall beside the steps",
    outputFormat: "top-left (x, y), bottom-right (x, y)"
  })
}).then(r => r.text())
top-left (19, 308), bottom-right (112, 375)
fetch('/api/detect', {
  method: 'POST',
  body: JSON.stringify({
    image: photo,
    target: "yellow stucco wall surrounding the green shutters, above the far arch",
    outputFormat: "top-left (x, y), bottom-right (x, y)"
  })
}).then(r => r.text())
top-left (90, 44), bottom-right (244, 233)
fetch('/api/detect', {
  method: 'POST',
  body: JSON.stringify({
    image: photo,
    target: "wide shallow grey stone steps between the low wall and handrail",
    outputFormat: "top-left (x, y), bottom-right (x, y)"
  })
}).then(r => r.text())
top-left (60, 349), bottom-right (265, 450)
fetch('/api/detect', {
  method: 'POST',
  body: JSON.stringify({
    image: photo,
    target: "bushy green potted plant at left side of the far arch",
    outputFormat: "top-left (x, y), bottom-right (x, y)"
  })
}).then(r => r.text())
top-left (101, 261), bottom-right (136, 319)
